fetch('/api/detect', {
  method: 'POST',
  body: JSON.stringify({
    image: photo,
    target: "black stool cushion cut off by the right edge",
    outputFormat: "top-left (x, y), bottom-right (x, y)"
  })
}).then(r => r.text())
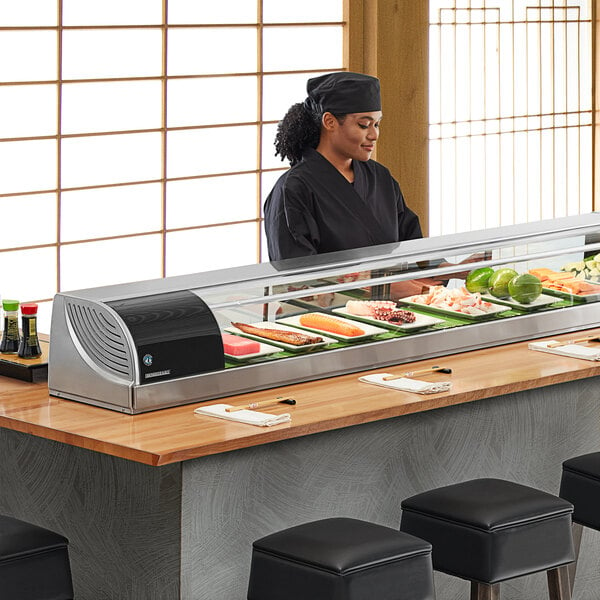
top-left (560, 452), bottom-right (600, 531)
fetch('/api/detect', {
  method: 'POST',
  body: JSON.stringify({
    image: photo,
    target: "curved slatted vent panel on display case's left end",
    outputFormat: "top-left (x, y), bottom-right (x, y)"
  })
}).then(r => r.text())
top-left (66, 302), bottom-right (134, 380)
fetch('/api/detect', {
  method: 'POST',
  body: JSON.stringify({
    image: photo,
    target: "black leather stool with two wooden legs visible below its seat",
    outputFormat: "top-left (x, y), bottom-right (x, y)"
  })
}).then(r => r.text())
top-left (400, 479), bottom-right (574, 600)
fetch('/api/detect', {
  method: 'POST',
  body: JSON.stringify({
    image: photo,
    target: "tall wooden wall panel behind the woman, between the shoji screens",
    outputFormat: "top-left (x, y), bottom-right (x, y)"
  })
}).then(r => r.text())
top-left (346, 0), bottom-right (429, 234)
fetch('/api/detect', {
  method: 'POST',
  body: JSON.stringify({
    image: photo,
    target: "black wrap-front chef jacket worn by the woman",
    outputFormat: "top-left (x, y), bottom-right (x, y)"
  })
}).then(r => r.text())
top-left (265, 149), bottom-right (423, 260)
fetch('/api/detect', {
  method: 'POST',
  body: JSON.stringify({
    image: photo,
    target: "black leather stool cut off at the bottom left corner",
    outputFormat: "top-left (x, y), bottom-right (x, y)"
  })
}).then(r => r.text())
top-left (0, 515), bottom-right (73, 600)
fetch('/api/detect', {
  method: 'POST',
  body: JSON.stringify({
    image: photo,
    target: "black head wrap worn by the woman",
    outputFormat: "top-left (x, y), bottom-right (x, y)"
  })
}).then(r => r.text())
top-left (304, 71), bottom-right (381, 115)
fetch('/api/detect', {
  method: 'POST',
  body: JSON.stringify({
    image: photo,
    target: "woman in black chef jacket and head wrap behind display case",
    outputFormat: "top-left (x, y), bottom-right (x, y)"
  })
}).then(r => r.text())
top-left (265, 72), bottom-right (422, 260)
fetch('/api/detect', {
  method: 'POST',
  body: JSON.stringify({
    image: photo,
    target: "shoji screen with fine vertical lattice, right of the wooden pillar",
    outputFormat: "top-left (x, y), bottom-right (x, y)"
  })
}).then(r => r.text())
top-left (429, 0), bottom-right (592, 235)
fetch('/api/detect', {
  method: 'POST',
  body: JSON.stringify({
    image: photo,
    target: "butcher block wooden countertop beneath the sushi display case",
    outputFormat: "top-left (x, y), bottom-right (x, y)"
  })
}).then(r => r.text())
top-left (0, 329), bottom-right (600, 466)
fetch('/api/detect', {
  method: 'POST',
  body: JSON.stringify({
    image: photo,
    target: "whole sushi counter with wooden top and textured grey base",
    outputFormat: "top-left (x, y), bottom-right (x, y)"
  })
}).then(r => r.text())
top-left (0, 328), bottom-right (600, 600)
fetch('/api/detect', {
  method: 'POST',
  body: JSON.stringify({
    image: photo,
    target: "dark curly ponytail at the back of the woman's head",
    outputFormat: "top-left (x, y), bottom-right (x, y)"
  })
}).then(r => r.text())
top-left (275, 102), bottom-right (321, 167)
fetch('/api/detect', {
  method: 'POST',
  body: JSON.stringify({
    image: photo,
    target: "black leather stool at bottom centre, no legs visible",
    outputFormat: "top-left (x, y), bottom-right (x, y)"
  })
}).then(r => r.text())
top-left (248, 518), bottom-right (434, 600)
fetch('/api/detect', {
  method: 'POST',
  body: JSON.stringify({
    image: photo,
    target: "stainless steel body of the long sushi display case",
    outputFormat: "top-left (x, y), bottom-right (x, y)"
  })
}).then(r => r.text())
top-left (49, 213), bottom-right (600, 414)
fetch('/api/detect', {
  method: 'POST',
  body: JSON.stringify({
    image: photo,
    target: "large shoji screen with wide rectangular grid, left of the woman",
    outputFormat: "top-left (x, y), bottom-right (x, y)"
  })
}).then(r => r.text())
top-left (0, 0), bottom-right (345, 331)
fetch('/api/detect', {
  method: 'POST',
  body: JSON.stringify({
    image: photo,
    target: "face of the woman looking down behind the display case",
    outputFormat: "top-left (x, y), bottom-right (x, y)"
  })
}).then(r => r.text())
top-left (331, 111), bottom-right (382, 161)
